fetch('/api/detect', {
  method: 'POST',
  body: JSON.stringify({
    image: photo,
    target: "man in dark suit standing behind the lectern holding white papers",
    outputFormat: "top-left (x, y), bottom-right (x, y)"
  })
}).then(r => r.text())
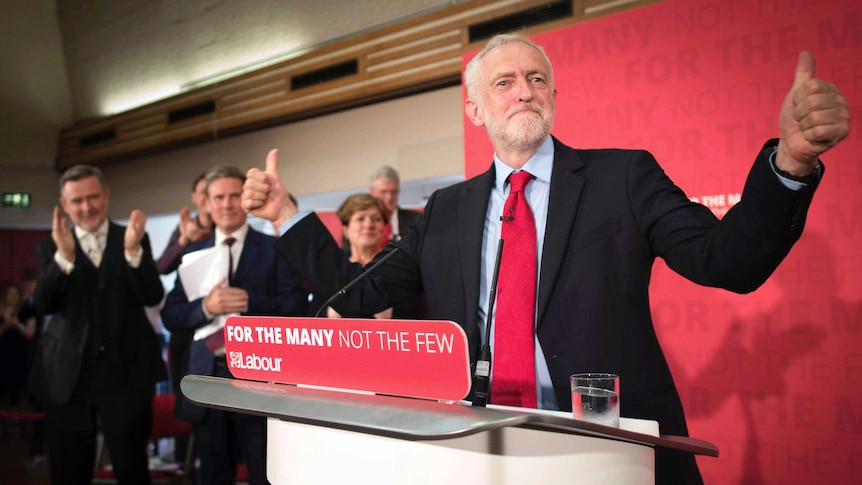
top-left (162, 167), bottom-right (308, 485)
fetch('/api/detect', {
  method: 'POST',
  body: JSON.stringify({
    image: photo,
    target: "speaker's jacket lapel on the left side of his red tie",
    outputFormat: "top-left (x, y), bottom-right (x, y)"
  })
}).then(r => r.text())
top-left (457, 164), bottom-right (494, 328)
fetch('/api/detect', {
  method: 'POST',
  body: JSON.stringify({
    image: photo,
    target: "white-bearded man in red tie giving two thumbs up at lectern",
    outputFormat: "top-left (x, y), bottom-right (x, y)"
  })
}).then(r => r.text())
top-left (243, 35), bottom-right (849, 484)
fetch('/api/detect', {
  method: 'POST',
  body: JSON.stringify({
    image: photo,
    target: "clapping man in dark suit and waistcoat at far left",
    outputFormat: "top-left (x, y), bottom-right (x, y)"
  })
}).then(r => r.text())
top-left (34, 165), bottom-right (166, 484)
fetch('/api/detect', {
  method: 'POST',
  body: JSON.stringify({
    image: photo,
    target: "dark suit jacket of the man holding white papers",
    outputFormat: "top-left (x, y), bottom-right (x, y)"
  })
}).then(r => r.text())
top-left (162, 227), bottom-right (308, 423)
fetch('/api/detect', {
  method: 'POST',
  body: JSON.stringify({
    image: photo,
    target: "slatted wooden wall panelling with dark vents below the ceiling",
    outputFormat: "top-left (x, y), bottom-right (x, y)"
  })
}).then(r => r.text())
top-left (56, 0), bottom-right (657, 170)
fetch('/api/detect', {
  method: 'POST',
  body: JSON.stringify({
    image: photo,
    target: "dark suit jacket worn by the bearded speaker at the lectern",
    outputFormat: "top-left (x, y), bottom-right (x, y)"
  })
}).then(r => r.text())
top-left (277, 139), bottom-right (816, 435)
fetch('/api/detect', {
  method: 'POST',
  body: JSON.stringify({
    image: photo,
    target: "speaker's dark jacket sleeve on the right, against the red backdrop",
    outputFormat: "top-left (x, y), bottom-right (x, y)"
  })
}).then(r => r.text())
top-left (644, 140), bottom-right (817, 293)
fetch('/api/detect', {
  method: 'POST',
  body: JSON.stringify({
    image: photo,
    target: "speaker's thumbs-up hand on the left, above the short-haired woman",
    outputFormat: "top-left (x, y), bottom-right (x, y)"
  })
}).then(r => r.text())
top-left (242, 149), bottom-right (298, 229)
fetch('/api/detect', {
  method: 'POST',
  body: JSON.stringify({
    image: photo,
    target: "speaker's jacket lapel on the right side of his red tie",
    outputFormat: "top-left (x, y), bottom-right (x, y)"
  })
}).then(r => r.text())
top-left (537, 138), bottom-right (585, 325)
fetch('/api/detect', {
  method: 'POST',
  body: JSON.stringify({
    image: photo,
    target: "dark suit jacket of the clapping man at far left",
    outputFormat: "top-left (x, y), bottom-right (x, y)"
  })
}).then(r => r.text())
top-left (34, 223), bottom-right (167, 404)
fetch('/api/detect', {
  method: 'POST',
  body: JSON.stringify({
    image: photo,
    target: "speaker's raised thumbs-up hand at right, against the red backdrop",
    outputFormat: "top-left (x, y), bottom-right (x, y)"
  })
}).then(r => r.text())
top-left (775, 51), bottom-right (850, 177)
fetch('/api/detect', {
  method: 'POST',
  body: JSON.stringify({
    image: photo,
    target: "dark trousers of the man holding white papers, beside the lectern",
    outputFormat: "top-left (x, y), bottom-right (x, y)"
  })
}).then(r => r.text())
top-left (194, 364), bottom-right (269, 485)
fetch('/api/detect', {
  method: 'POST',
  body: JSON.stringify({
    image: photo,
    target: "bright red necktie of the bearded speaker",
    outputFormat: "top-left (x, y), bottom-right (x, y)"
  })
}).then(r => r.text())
top-left (491, 171), bottom-right (536, 408)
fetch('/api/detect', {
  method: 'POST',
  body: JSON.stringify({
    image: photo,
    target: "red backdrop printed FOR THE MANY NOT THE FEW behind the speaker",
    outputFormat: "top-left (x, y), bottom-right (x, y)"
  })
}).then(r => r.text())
top-left (464, 0), bottom-right (862, 484)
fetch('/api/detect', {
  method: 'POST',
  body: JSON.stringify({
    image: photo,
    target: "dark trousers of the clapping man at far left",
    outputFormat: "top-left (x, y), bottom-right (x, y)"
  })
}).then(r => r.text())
top-left (44, 382), bottom-right (155, 485)
